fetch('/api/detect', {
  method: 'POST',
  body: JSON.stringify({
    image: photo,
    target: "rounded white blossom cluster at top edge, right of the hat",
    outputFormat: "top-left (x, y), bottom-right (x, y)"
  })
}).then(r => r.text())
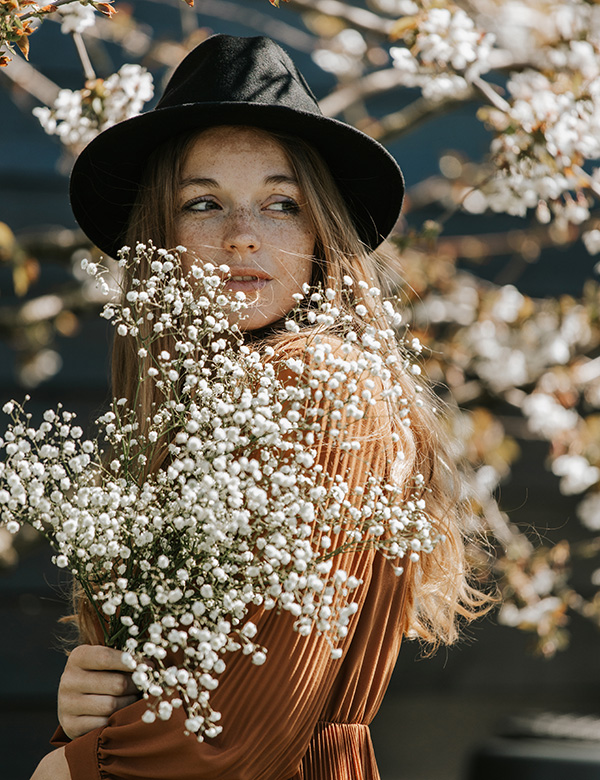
top-left (390, 4), bottom-right (494, 101)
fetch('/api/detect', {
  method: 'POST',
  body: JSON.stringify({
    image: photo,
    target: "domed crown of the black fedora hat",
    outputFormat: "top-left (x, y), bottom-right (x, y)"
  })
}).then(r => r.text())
top-left (156, 35), bottom-right (321, 114)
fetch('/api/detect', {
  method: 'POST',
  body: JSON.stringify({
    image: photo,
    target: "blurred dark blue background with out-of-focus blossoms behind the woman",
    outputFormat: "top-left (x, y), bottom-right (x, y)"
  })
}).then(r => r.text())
top-left (0, 0), bottom-right (600, 780)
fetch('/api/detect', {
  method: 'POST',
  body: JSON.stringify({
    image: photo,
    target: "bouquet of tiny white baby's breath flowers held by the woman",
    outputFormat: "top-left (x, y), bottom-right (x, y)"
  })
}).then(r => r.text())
top-left (0, 244), bottom-right (438, 740)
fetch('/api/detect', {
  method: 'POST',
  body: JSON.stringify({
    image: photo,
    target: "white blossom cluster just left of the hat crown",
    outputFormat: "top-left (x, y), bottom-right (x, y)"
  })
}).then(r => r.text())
top-left (33, 64), bottom-right (154, 151)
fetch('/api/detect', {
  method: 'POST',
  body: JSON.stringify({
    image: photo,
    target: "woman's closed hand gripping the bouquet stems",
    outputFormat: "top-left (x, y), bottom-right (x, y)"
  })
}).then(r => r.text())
top-left (57, 645), bottom-right (138, 740)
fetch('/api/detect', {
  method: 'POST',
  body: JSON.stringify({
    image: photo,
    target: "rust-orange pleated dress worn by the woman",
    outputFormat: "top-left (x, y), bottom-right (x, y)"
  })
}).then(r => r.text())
top-left (54, 336), bottom-right (407, 780)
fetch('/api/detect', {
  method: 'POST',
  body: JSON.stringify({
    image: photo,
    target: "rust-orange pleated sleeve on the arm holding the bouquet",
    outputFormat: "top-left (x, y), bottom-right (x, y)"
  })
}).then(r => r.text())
top-left (65, 336), bottom-right (408, 780)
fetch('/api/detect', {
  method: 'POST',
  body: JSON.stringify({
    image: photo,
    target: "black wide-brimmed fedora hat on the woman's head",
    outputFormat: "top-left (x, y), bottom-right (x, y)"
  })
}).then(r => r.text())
top-left (71, 35), bottom-right (404, 257)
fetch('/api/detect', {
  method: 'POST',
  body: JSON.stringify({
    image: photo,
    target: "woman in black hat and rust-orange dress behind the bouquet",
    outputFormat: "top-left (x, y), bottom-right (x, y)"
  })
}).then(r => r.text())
top-left (34, 36), bottom-right (486, 780)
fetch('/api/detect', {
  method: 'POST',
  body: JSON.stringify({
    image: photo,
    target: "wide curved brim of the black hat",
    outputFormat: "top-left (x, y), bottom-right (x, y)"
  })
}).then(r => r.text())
top-left (70, 102), bottom-right (404, 257)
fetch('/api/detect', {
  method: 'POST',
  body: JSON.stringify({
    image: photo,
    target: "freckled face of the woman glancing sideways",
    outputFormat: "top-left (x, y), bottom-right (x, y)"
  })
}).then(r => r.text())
top-left (175, 126), bottom-right (315, 330)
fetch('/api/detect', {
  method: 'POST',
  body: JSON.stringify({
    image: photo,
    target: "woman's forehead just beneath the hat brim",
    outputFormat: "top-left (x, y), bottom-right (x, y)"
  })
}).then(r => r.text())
top-left (183, 125), bottom-right (291, 171)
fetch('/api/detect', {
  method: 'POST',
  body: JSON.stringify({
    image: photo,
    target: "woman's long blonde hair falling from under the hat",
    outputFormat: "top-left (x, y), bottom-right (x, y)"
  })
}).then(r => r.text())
top-left (78, 125), bottom-right (491, 646)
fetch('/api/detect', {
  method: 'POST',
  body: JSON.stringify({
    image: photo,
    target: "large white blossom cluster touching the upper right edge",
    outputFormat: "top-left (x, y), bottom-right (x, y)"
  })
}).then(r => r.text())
top-left (482, 66), bottom-right (600, 224)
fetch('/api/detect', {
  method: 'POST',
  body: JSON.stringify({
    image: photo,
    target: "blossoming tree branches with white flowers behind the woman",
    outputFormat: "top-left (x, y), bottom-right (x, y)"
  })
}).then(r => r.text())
top-left (0, 0), bottom-right (600, 655)
